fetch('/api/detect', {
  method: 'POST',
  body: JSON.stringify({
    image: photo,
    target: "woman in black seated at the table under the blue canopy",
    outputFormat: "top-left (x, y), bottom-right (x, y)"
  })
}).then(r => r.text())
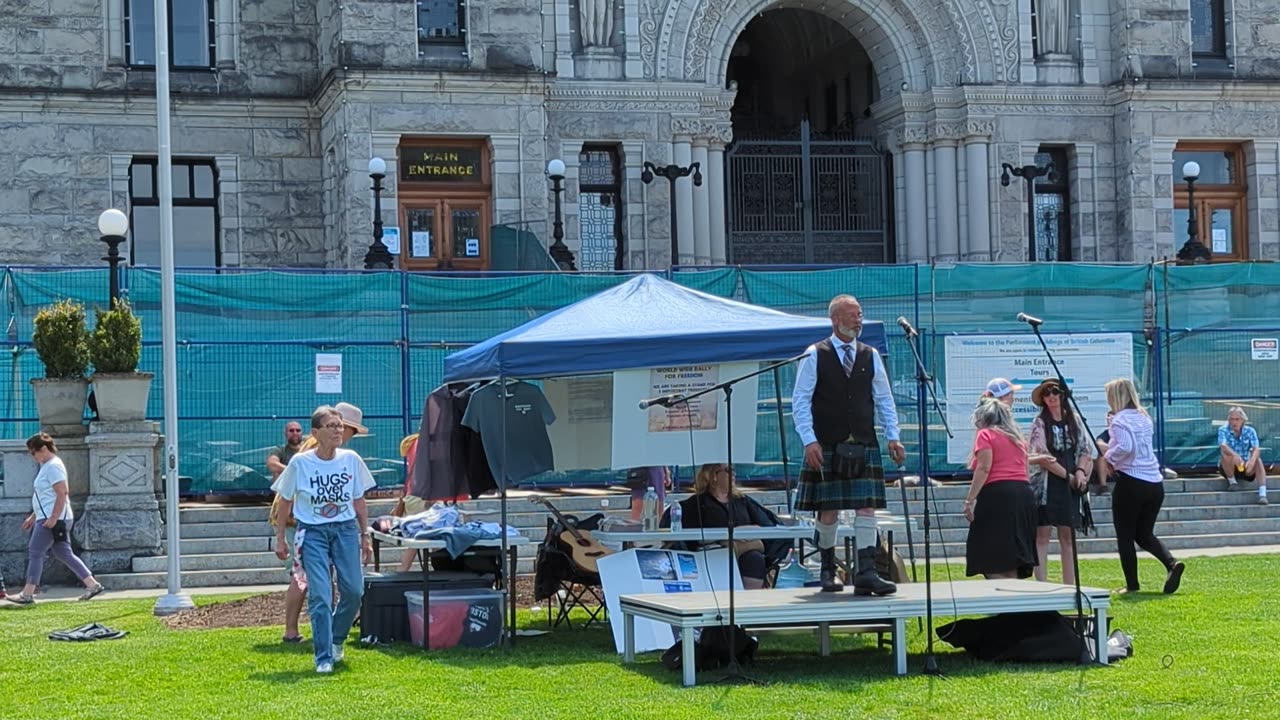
top-left (662, 462), bottom-right (788, 589)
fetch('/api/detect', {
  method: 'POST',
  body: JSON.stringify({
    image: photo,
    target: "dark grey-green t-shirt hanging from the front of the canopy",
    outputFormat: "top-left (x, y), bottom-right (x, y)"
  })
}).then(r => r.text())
top-left (462, 382), bottom-right (556, 484)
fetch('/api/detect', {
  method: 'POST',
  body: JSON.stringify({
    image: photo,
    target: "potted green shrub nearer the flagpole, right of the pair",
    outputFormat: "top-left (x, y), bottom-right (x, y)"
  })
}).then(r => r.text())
top-left (90, 299), bottom-right (154, 421)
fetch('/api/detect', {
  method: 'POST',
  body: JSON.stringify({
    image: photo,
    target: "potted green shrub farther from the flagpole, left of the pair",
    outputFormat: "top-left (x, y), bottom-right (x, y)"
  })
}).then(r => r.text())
top-left (31, 300), bottom-right (90, 427)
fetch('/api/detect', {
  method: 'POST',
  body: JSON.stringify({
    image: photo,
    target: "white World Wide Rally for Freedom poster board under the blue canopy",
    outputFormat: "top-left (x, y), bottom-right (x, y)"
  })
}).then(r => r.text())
top-left (611, 363), bottom-right (760, 470)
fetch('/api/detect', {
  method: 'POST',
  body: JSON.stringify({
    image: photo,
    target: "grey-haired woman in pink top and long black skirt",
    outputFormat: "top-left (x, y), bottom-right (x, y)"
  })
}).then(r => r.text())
top-left (964, 397), bottom-right (1038, 580)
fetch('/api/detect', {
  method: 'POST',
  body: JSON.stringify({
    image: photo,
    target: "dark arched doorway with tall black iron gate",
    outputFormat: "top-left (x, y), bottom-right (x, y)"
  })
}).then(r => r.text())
top-left (724, 8), bottom-right (893, 265)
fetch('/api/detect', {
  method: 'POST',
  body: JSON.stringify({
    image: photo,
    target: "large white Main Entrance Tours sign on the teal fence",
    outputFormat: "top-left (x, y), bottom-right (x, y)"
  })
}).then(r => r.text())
top-left (943, 333), bottom-right (1133, 464)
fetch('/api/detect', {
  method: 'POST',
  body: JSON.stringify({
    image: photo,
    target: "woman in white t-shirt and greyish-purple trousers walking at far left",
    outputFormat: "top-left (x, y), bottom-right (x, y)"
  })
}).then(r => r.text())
top-left (5, 433), bottom-right (102, 605)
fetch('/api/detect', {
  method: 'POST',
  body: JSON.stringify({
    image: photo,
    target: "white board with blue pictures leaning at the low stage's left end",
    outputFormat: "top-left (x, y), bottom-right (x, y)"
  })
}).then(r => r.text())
top-left (596, 547), bottom-right (742, 655)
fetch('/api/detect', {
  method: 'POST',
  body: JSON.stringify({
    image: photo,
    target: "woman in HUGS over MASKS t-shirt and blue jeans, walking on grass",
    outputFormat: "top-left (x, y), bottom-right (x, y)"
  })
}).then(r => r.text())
top-left (271, 405), bottom-right (374, 673)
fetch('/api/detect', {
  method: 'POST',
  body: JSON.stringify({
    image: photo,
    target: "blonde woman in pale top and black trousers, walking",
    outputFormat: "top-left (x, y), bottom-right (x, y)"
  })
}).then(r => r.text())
top-left (1103, 378), bottom-right (1185, 593)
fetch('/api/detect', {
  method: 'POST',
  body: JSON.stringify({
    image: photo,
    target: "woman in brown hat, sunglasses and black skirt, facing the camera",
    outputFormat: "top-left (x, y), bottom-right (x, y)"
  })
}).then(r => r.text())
top-left (1030, 379), bottom-right (1093, 585)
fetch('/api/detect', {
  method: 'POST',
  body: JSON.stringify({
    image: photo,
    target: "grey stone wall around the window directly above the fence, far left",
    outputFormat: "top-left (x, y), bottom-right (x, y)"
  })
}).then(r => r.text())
top-left (0, 97), bottom-right (324, 265)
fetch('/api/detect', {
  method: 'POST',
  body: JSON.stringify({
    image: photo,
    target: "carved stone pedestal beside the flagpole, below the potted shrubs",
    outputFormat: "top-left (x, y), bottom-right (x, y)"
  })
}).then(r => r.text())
top-left (74, 421), bottom-right (163, 574)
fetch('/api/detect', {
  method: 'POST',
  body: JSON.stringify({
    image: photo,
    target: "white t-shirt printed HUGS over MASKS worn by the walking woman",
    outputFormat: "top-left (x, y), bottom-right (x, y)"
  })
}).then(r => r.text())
top-left (271, 447), bottom-right (376, 525)
